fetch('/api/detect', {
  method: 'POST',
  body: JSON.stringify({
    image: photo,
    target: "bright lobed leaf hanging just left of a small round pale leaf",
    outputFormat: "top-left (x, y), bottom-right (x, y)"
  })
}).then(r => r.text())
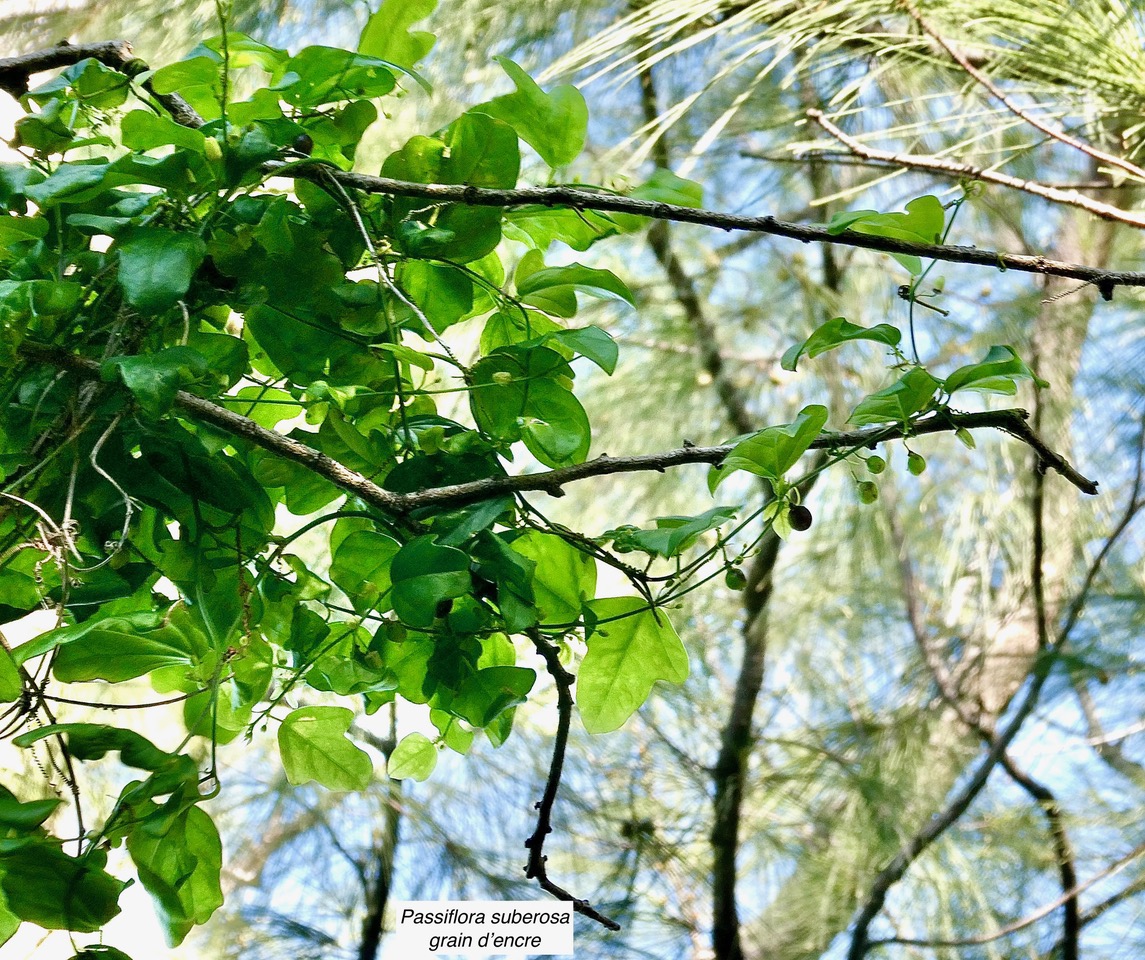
top-left (278, 707), bottom-right (373, 790)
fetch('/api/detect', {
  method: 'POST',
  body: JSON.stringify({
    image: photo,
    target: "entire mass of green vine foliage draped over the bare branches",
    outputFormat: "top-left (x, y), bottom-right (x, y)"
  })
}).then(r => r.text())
top-left (0, 0), bottom-right (1048, 943)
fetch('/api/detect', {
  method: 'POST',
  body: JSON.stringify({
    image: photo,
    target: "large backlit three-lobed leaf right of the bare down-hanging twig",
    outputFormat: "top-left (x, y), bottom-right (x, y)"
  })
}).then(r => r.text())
top-left (576, 597), bottom-right (688, 733)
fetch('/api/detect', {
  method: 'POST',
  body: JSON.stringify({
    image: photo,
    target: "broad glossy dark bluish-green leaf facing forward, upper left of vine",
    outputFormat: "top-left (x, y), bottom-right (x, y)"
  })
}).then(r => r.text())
top-left (116, 227), bottom-right (206, 315)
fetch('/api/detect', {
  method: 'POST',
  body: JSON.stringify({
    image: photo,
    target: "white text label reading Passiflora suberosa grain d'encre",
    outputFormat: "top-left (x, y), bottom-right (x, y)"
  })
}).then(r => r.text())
top-left (386, 900), bottom-right (573, 960)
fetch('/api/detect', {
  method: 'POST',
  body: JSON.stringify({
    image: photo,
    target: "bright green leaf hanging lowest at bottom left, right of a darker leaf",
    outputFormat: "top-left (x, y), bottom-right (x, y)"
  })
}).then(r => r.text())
top-left (127, 806), bottom-right (223, 946)
